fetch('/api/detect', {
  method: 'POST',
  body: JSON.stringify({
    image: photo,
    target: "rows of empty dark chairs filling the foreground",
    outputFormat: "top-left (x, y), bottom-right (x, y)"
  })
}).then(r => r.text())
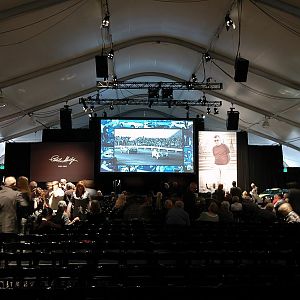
top-left (0, 220), bottom-right (300, 299)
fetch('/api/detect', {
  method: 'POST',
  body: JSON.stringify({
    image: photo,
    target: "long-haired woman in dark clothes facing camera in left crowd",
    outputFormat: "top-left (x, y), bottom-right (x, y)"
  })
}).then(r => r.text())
top-left (67, 180), bottom-right (91, 221)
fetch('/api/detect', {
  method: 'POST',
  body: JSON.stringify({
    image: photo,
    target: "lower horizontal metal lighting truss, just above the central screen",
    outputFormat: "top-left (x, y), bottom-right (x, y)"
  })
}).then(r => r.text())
top-left (79, 96), bottom-right (222, 108)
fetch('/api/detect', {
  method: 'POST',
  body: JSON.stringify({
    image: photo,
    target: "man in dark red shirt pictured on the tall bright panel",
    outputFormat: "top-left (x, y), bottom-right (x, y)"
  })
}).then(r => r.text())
top-left (212, 135), bottom-right (230, 183)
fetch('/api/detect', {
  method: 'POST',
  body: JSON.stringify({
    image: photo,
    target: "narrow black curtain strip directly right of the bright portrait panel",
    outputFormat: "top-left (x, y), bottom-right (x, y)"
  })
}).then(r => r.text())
top-left (237, 131), bottom-right (249, 191)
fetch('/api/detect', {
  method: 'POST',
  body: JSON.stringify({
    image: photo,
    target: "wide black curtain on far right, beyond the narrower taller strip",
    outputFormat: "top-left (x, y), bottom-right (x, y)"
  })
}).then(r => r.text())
top-left (247, 146), bottom-right (284, 192)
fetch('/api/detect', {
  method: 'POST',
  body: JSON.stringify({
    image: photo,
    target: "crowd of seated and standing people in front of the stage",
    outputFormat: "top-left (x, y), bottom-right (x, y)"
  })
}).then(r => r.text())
top-left (0, 176), bottom-right (300, 234)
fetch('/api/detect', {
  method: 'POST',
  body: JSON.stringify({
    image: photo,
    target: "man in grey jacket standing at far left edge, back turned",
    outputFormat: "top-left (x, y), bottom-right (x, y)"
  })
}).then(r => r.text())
top-left (0, 176), bottom-right (28, 233)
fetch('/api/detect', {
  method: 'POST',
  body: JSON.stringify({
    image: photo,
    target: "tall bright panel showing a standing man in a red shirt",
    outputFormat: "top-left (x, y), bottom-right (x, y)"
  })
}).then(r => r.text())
top-left (198, 131), bottom-right (237, 193)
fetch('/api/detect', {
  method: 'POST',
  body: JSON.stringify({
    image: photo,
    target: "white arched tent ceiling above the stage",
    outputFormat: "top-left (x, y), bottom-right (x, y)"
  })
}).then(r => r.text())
top-left (0, 0), bottom-right (300, 155)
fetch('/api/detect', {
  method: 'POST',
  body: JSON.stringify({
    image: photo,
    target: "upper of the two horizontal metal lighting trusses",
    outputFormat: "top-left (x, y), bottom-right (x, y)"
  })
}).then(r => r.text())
top-left (97, 80), bottom-right (223, 91)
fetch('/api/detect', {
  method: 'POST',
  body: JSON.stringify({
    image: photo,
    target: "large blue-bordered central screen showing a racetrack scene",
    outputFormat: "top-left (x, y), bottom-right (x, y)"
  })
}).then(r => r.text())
top-left (99, 119), bottom-right (194, 173)
